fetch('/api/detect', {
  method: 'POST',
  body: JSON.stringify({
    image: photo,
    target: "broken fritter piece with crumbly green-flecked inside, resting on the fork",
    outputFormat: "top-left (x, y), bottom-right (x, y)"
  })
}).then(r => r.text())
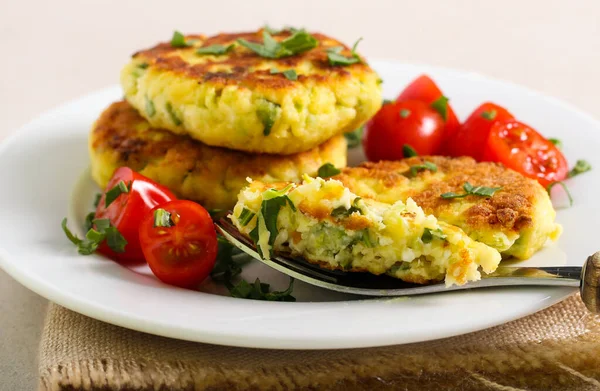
top-left (230, 178), bottom-right (501, 285)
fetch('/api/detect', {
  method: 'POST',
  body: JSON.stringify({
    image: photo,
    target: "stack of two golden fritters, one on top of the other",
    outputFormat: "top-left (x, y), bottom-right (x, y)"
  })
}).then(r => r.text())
top-left (89, 30), bottom-right (381, 209)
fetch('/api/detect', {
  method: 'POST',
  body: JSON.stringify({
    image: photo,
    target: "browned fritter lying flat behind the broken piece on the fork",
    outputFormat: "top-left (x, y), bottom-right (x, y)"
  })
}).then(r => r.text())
top-left (335, 156), bottom-right (561, 259)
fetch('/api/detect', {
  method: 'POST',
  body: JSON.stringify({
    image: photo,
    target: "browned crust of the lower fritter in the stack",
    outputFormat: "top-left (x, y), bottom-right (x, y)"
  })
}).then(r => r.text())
top-left (91, 101), bottom-right (344, 175)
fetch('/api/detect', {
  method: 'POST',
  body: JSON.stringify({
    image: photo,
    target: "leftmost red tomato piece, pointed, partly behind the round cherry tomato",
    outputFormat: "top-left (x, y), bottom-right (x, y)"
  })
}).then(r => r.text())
top-left (96, 167), bottom-right (177, 262)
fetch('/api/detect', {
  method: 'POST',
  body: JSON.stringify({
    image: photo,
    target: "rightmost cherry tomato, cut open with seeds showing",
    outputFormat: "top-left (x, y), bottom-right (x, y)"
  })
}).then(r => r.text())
top-left (484, 120), bottom-right (569, 187)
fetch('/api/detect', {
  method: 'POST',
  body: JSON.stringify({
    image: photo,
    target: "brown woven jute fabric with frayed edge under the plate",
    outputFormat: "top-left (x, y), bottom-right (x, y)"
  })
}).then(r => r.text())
top-left (39, 295), bottom-right (600, 391)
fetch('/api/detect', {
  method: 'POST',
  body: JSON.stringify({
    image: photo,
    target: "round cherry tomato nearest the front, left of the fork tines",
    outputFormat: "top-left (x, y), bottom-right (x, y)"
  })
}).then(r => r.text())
top-left (140, 200), bottom-right (218, 288)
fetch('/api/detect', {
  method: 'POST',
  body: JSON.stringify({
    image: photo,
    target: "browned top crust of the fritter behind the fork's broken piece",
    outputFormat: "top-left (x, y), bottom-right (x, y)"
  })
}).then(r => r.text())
top-left (334, 156), bottom-right (544, 231)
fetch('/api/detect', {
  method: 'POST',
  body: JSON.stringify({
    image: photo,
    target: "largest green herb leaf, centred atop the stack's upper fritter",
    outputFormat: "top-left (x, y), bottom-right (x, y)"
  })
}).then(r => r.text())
top-left (237, 30), bottom-right (319, 58)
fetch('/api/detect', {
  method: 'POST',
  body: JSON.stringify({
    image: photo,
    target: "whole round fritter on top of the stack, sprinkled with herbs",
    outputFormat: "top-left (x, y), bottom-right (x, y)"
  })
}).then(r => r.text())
top-left (121, 30), bottom-right (381, 154)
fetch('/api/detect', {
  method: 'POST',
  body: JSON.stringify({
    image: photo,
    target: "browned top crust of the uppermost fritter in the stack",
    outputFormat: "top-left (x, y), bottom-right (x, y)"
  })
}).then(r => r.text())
top-left (133, 29), bottom-right (370, 89)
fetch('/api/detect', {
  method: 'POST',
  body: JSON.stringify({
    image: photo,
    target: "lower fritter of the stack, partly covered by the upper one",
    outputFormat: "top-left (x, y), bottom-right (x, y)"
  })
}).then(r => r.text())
top-left (89, 101), bottom-right (347, 210)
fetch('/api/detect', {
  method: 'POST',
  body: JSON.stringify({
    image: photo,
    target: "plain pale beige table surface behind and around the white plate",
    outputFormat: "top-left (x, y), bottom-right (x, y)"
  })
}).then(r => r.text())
top-left (0, 0), bottom-right (600, 391)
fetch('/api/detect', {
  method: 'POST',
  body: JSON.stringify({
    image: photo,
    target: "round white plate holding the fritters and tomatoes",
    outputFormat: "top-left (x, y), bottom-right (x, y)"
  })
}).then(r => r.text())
top-left (0, 62), bottom-right (600, 349)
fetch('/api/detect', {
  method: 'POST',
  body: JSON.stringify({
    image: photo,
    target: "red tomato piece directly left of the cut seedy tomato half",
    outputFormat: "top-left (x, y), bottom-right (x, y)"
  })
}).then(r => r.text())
top-left (442, 102), bottom-right (514, 160)
